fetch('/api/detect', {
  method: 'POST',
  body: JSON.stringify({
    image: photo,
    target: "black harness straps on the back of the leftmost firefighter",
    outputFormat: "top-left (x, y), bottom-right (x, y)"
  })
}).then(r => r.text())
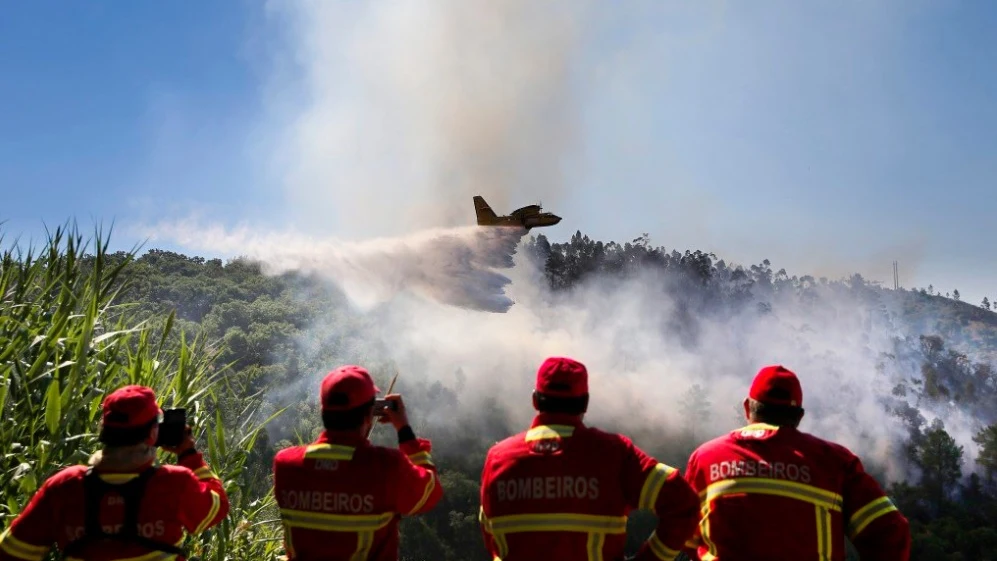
top-left (63, 466), bottom-right (186, 556)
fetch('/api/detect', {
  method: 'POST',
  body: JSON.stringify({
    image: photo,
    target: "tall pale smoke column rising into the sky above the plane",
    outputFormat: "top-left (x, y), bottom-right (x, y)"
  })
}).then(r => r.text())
top-left (262, 0), bottom-right (587, 237)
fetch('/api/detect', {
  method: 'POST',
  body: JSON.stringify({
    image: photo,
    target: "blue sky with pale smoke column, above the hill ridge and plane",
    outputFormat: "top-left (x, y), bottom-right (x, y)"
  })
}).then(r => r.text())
top-left (0, 1), bottom-right (997, 302)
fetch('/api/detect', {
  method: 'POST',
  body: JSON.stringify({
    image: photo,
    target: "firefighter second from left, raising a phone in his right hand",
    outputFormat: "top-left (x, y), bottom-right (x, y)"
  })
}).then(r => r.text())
top-left (273, 365), bottom-right (443, 561)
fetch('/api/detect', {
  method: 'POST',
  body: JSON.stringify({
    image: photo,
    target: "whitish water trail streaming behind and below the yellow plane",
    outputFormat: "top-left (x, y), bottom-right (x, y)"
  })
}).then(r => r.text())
top-left (147, 221), bottom-right (526, 312)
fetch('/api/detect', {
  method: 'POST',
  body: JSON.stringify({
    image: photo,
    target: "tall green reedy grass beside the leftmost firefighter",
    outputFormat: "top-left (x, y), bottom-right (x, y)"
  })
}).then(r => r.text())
top-left (0, 224), bottom-right (281, 561)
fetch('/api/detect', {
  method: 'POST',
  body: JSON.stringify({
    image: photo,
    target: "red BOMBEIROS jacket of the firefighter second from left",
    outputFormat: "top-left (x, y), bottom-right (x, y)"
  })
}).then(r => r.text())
top-left (273, 431), bottom-right (443, 561)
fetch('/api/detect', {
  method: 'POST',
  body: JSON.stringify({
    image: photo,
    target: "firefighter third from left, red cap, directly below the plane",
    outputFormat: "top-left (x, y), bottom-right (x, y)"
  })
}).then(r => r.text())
top-left (480, 357), bottom-right (698, 561)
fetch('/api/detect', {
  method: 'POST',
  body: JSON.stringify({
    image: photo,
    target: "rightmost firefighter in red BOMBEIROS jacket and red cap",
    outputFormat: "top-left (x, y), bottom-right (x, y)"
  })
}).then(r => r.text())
top-left (685, 365), bottom-right (910, 561)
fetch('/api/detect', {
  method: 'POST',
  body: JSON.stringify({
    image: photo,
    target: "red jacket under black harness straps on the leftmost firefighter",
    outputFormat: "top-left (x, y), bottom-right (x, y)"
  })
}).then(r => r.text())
top-left (0, 452), bottom-right (229, 561)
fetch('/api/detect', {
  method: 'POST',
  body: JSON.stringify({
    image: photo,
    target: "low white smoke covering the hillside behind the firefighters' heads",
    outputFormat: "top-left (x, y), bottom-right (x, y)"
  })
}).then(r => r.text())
top-left (362, 257), bottom-right (907, 478)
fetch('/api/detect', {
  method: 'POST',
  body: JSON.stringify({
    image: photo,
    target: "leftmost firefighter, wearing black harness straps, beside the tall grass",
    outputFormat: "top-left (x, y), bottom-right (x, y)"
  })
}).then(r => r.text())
top-left (0, 385), bottom-right (229, 561)
